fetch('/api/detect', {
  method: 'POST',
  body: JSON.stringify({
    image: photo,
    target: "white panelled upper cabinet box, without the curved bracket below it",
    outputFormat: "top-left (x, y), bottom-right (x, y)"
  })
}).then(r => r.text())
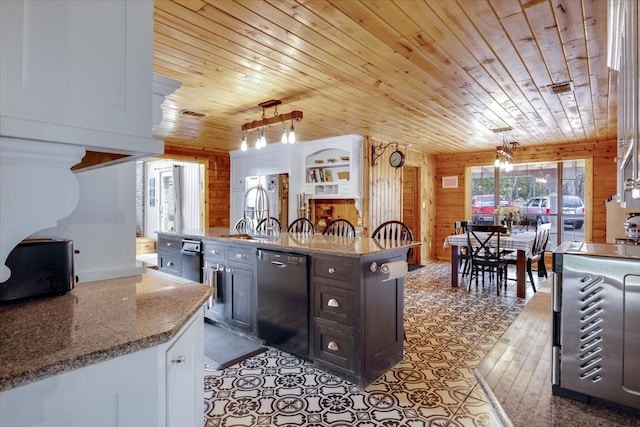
top-left (0, 0), bottom-right (163, 154)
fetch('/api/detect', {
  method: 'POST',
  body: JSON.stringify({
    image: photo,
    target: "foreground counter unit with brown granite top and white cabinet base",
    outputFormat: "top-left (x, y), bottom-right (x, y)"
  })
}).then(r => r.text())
top-left (0, 272), bottom-right (211, 427)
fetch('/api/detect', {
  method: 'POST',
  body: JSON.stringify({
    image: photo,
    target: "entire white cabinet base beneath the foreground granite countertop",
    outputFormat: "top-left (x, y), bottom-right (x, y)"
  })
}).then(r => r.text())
top-left (0, 310), bottom-right (204, 427)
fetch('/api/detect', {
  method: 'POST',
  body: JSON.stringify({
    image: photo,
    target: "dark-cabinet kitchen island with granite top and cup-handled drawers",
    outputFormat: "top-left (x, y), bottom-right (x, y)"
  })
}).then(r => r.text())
top-left (158, 228), bottom-right (420, 387)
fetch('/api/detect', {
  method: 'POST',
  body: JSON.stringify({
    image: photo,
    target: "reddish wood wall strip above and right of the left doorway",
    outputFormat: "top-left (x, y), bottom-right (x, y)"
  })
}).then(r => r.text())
top-left (164, 145), bottom-right (231, 227)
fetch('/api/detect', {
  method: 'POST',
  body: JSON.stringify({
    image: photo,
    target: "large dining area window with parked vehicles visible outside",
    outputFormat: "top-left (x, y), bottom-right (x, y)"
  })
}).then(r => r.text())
top-left (471, 160), bottom-right (587, 245)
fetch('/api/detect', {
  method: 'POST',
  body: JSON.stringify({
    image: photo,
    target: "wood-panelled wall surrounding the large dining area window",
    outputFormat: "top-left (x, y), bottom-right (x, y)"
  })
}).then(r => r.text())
top-left (434, 140), bottom-right (616, 259)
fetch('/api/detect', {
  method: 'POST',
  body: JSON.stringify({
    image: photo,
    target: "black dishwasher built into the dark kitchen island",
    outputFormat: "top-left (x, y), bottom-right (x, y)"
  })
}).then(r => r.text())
top-left (258, 249), bottom-right (309, 359)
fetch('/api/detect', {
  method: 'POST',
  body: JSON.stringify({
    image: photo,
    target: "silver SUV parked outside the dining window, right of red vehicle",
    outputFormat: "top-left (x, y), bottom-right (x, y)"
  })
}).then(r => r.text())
top-left (522, 195), bottom-right (584, 230)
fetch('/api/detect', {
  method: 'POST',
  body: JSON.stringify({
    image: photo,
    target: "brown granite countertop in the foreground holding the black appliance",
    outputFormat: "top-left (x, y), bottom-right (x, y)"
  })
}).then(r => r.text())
top-left (0, 272), bottom-right (211, 391)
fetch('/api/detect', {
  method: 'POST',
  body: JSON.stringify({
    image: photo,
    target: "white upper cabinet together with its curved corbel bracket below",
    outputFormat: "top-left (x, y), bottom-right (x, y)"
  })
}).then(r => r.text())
top-left (0, 0), bottom-right (165, 282)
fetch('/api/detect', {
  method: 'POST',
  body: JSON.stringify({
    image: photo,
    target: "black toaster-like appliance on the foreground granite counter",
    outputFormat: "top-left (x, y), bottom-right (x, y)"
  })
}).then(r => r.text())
top-left (0, 239), bottom-right (75, 302)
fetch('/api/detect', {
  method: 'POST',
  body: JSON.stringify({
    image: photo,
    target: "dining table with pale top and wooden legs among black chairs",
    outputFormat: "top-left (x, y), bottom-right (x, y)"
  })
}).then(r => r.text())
top-left (444, 230), bottom-right (544, 298)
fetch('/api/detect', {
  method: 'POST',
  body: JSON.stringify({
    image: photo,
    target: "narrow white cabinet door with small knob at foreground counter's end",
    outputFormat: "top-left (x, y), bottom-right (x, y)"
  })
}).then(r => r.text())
top-left (165, 310), bottom-right (204, 427)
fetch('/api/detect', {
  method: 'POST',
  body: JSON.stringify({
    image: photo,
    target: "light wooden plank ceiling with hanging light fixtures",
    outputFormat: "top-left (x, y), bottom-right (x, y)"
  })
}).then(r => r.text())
top-left (154, 0), bottom-right (616, 154)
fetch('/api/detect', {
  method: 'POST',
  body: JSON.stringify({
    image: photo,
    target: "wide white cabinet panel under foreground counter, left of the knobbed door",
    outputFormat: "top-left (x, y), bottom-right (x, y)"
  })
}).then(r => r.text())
top-left (0, 348), bottom-right (159, 427)
